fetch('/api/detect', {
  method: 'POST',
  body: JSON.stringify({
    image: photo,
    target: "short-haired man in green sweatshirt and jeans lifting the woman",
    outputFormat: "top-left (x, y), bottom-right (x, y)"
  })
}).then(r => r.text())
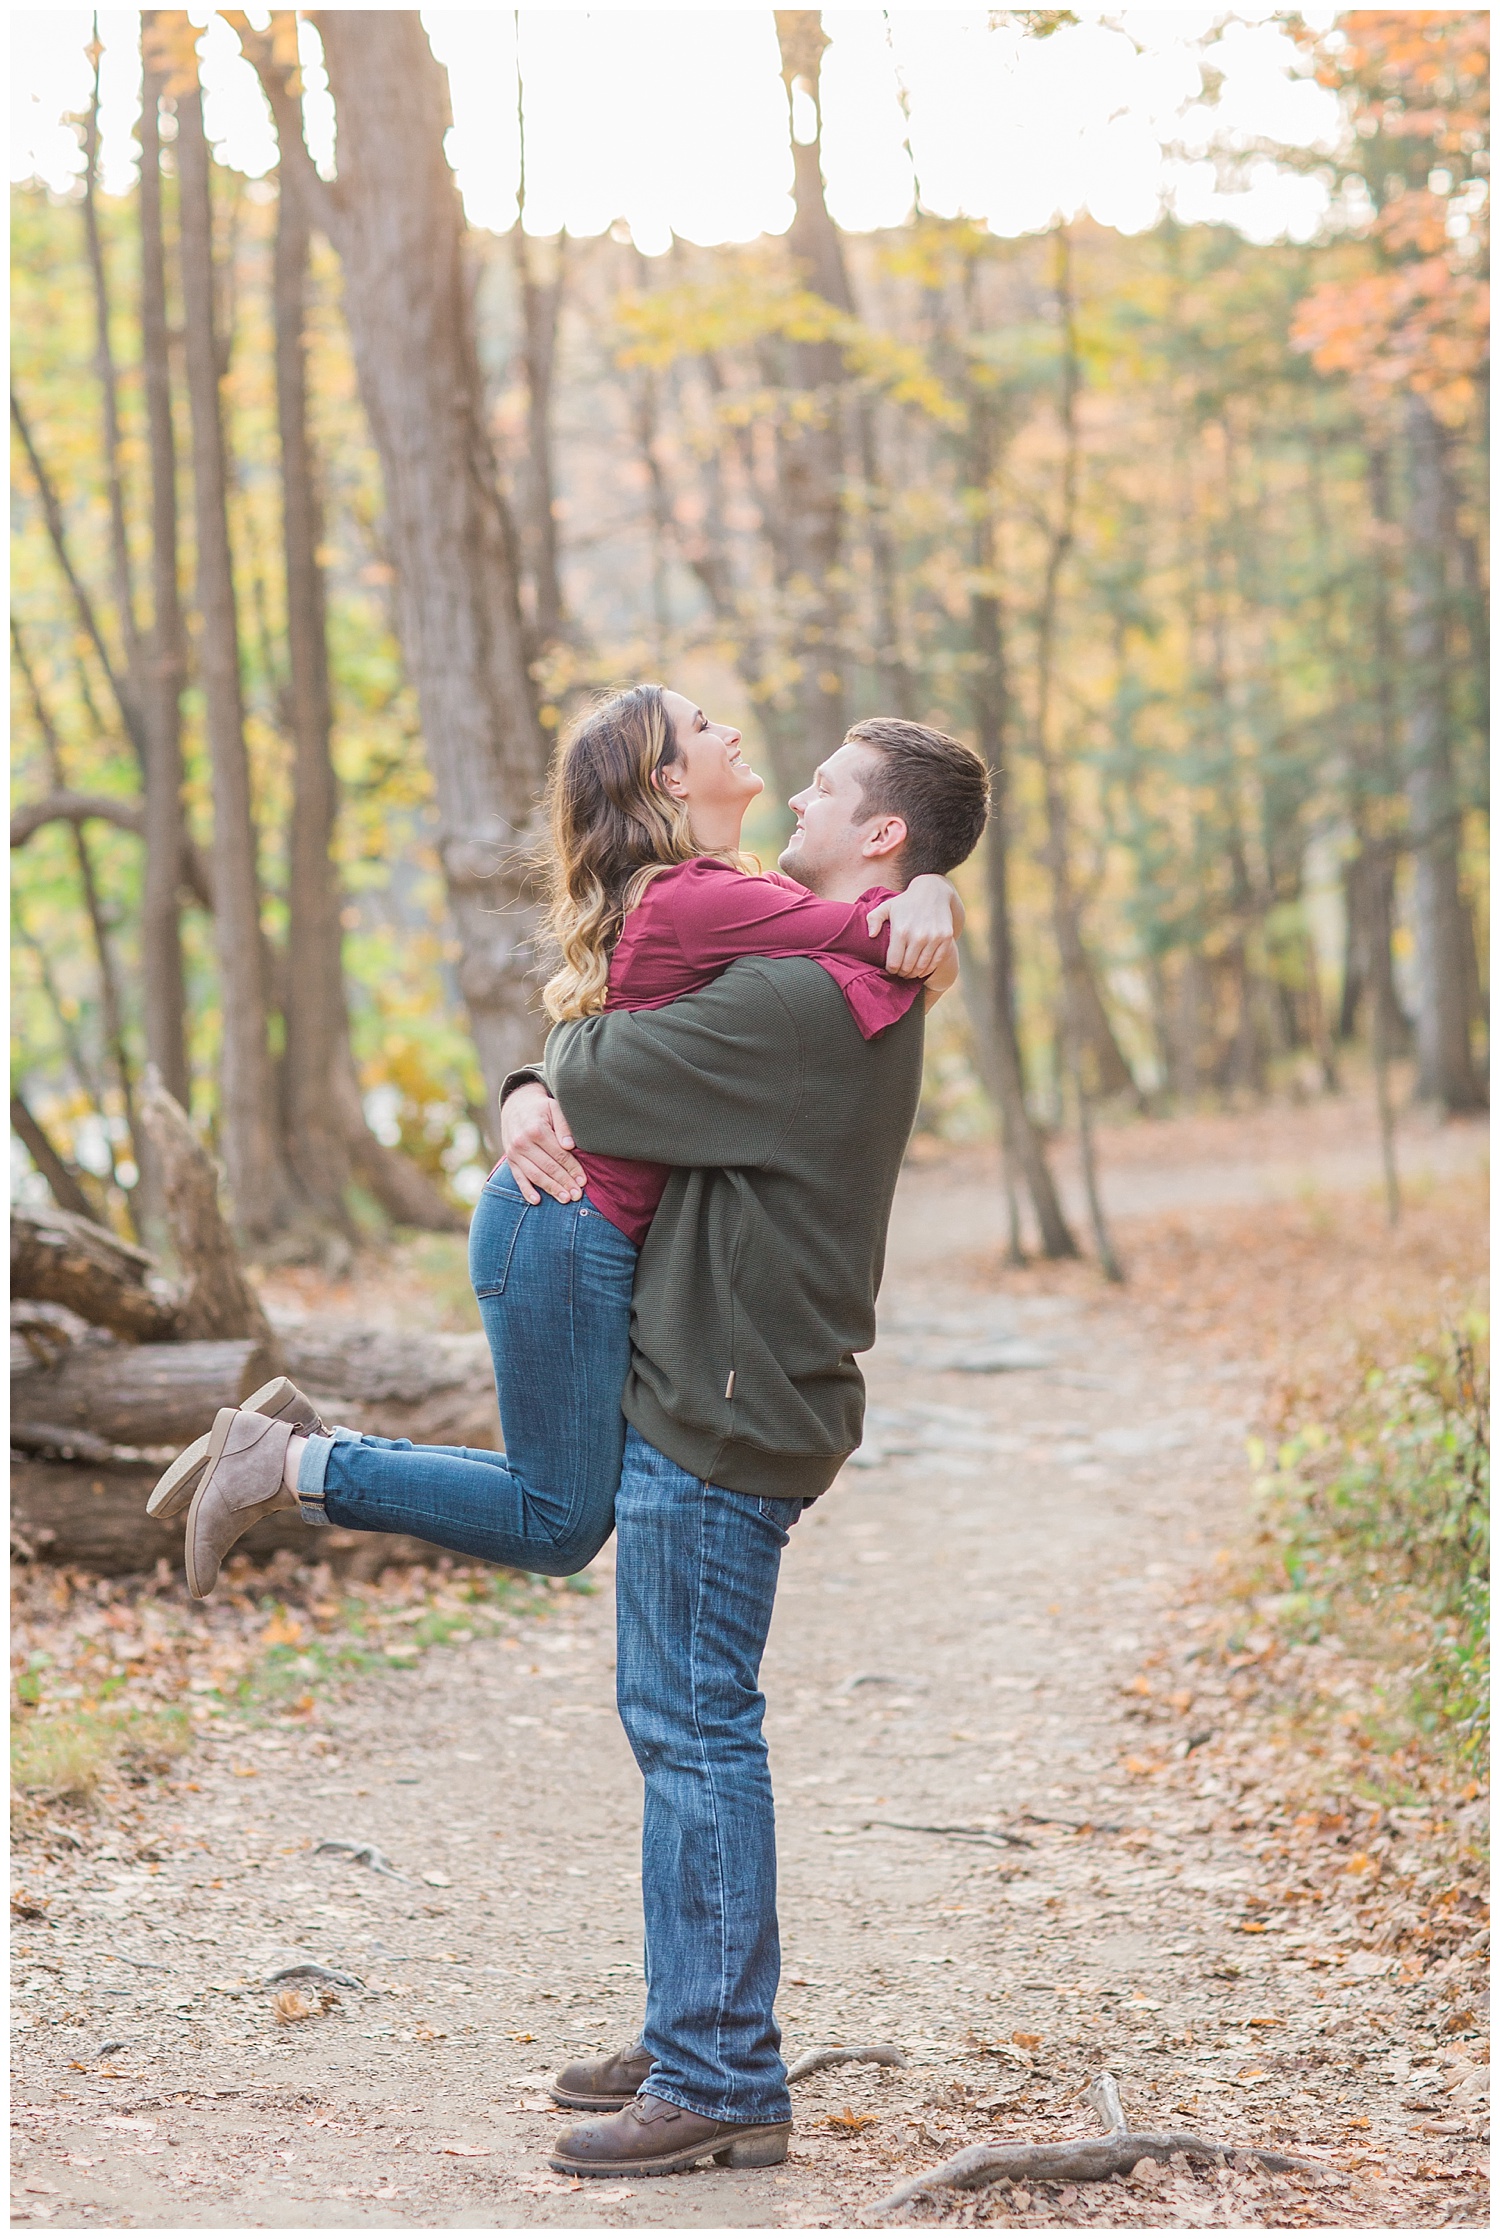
top-left (501, 719), bottom-right (987, 2176)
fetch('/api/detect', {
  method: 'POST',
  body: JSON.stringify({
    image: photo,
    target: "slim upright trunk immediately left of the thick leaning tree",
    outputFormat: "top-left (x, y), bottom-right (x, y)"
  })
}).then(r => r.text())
top-left (273, 174), bottom-right (349, 1227)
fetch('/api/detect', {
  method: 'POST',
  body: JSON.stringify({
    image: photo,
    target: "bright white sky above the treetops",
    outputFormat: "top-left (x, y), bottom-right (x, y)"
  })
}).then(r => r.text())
top-left (9, 0), bottom-right (1337, 255)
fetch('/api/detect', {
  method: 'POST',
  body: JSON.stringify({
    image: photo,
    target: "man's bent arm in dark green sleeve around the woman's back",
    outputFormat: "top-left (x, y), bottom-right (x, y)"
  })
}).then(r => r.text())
top-left (546, 958), bottom-right (810, 1167)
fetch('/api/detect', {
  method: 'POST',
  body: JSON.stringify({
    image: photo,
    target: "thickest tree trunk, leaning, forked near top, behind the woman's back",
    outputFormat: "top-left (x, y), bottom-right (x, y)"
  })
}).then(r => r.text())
top-left (262, 9), bottom-right (546, 1124)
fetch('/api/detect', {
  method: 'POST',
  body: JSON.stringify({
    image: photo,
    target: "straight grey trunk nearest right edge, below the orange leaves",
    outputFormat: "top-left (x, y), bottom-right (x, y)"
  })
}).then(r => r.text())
top-left (1406, 396), bottom-right (1484, 1113)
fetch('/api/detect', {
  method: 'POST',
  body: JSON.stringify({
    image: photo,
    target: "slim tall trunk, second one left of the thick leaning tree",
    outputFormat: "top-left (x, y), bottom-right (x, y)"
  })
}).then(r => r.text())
top-left (177, 85), bottom-right (291, 1240)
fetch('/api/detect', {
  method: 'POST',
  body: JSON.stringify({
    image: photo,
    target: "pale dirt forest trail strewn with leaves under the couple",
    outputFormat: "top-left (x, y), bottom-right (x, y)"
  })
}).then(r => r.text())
top-left (13, 1110), bottom-right (1487, 2228)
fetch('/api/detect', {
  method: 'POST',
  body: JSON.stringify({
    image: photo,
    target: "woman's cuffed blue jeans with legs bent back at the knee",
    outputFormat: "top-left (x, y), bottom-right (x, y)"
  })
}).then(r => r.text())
top-left (298, 1167), bottom-right (636, 1578)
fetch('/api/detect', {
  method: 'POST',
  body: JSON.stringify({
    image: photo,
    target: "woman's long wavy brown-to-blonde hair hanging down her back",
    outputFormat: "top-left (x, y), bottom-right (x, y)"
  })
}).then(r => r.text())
top-left (542, 685), bottom-right (705, 1019)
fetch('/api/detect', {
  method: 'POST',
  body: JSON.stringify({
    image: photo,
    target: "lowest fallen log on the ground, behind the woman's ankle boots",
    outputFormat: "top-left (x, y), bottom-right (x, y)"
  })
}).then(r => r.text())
top-left (11, 1455), bottom-right (447, 1578)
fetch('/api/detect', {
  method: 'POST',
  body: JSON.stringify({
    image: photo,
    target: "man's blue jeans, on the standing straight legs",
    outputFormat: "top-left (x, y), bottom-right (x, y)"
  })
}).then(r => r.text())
top-left (616, 1428), bottom-right (801, 2123)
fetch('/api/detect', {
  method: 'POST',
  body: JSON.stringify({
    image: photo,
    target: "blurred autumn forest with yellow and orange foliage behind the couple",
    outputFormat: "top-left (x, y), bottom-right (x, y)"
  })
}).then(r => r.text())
top-left (11, 11), bottom-right (1489, 1265)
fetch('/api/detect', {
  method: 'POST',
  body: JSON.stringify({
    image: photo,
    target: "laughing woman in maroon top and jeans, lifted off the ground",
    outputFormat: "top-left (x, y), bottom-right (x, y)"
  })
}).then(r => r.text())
top-left (148, 685), bottom-right (963, 1599)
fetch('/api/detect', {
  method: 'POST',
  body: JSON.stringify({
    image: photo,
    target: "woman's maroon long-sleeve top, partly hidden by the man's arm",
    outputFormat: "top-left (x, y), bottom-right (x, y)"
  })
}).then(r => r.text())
top-left (575, 855), bottom-right (922, 1245)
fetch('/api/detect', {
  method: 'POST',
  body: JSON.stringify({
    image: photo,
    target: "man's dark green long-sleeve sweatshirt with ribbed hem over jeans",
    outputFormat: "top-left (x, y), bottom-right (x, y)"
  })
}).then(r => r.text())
top-left (544, 956), bottom-right (922, 1500)
